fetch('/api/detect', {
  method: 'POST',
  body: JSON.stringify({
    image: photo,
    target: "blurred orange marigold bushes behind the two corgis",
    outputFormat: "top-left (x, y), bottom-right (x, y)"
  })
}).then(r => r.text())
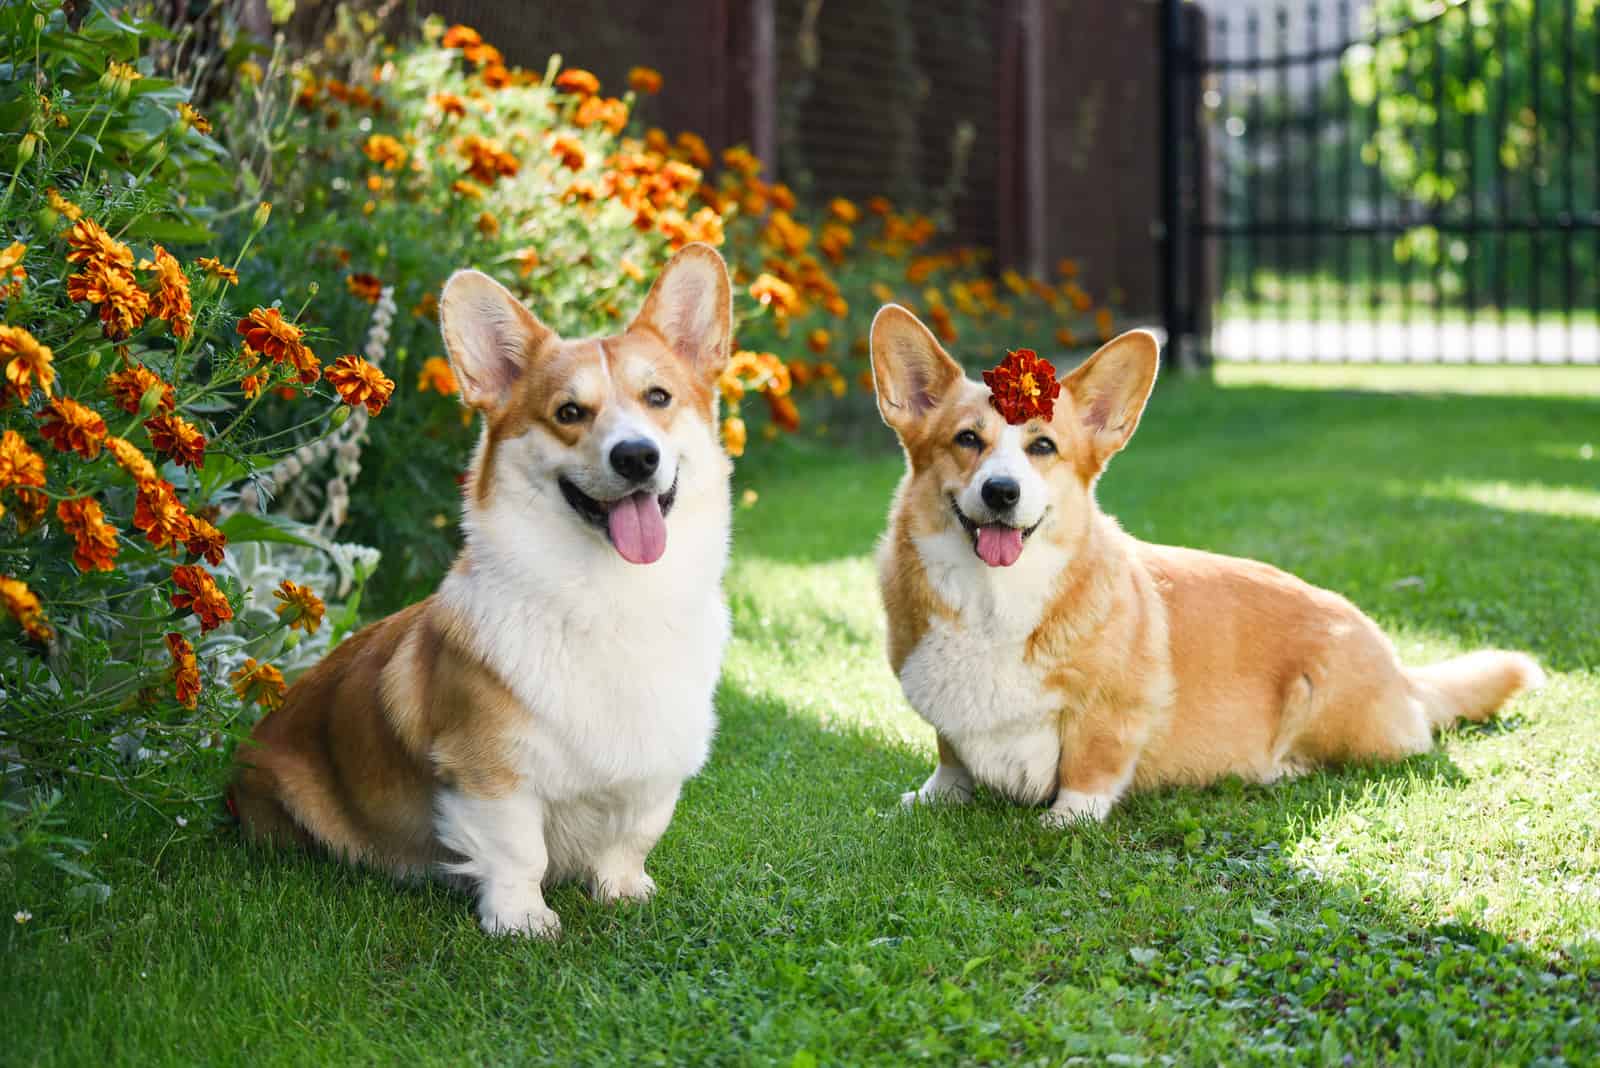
top-left (232, 13), bottom-right (1110, 609)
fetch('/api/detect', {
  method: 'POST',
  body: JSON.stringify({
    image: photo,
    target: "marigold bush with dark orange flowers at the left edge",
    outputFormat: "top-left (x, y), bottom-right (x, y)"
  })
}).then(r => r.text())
top-left (0, 2), bottom-right (379, 855)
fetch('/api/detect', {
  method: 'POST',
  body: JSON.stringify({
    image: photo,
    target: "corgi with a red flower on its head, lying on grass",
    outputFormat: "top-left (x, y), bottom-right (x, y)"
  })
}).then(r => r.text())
top-left (872, 305), bottom-right (1542, 823)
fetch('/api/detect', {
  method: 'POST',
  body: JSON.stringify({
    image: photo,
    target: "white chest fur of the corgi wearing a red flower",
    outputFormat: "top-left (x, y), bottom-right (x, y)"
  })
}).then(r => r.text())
top-left (899, 536), bottom-right (1061, 804)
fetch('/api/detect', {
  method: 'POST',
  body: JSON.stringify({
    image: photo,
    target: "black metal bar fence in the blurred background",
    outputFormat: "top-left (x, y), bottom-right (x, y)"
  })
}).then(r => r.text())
top-left (1163, 0), bottom-right (1600, 363)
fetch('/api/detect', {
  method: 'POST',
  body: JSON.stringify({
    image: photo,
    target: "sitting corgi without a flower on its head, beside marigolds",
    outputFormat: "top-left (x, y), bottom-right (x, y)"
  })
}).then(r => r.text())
top-left (232, 245), bottom-right (731, 935)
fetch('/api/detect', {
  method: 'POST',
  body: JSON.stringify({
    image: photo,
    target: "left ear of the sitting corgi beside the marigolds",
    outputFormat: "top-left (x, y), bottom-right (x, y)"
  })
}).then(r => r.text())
top-left (438, 270), bottom-right (555, 411)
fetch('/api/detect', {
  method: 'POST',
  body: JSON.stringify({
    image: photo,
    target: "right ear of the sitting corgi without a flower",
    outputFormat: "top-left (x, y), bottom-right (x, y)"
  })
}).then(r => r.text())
top-left (627, 241), bottom-right (733, 379)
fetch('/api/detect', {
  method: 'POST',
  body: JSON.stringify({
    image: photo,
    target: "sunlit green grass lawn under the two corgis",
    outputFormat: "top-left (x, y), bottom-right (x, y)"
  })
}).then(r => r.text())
top-left (0, 368), bottom-right (1600, 1065)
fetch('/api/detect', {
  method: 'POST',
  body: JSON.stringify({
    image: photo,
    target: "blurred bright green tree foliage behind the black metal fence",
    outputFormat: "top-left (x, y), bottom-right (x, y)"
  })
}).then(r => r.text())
top-left (1342, 0), bottom-right (1600, 282)
